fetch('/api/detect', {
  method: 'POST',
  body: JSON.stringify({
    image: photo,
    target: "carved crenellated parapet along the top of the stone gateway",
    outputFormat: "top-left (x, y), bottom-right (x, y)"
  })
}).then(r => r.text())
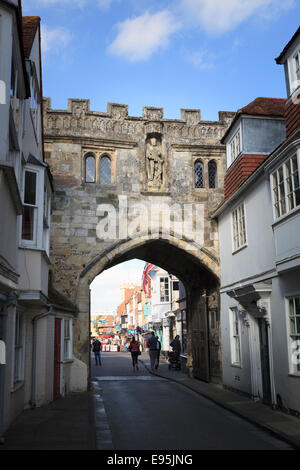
top-left (44, 98), bottom-right (235, 145)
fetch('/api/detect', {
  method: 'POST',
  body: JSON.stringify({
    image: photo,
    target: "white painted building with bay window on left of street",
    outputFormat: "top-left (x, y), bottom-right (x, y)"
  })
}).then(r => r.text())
top-left (0, 1), bottom-right (80, 439)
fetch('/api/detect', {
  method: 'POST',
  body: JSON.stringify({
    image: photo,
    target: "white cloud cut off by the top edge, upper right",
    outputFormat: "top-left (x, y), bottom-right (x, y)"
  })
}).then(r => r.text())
top-left (180, 0), bottom-right (294, 34)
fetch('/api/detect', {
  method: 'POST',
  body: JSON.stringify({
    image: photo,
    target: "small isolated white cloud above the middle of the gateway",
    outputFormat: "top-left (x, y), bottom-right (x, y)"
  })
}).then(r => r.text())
top-left (108, 10), bottom-right (179, 62)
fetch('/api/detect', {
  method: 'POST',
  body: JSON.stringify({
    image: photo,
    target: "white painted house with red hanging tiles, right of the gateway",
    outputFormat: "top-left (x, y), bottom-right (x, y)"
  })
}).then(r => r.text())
top-left (214, 28), bottom-right (300, 416)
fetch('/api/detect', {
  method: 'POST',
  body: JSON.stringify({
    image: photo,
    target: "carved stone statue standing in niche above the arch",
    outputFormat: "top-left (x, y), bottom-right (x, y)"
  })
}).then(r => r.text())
top-left (146, 137), bottom-right (165, 189)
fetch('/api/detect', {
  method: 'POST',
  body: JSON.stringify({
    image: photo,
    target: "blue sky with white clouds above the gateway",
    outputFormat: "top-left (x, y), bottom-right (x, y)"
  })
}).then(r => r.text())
top-left (23, 0), bottom-right (300, 120)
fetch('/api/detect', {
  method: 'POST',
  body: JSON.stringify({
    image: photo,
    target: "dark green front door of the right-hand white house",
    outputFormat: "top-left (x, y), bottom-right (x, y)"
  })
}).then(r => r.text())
top-left (258, 318), bottom-right (272, 405)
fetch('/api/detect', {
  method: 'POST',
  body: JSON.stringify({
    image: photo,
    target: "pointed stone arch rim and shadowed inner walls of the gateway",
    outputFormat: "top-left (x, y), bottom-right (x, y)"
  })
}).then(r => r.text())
top-left (75, 238), bottom-right (221, 382)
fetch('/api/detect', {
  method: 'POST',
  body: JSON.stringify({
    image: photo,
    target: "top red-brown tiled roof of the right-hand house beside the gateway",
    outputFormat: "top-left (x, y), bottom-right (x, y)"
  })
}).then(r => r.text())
top-left (221, 97), bottom-right (286, 143)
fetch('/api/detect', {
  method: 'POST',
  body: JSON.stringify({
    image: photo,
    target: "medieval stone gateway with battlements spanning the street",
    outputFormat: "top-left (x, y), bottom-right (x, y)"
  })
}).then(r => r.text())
top-left (43, 98), bottom-right (234, 388)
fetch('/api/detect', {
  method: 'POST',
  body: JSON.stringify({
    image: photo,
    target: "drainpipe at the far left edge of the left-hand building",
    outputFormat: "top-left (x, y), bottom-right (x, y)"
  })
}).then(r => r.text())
top-left (0, 292), bottom-right (17, 444)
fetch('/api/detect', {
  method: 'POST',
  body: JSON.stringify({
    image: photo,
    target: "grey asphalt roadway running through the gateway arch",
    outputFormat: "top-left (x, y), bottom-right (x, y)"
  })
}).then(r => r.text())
top-left (91, 352), bottom-right (291, 450)
